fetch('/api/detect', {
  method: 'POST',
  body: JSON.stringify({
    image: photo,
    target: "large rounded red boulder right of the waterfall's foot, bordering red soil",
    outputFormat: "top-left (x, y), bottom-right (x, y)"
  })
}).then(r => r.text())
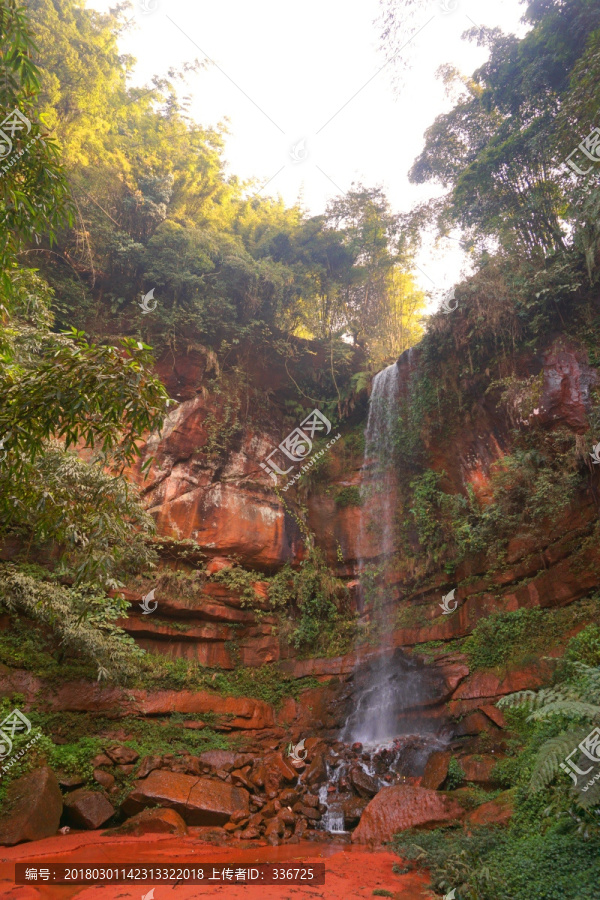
top-left (352, 785), bottom-right (464, 844)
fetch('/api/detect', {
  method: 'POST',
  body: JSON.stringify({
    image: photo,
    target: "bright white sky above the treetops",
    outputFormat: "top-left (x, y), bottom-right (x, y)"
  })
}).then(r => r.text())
top-left (88, 0), bottom-right (524, 307)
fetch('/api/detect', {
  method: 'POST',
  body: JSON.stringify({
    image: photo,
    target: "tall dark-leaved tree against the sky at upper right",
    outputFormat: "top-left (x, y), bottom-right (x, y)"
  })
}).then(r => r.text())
top-left (398, 0), bottom-right (600, 254)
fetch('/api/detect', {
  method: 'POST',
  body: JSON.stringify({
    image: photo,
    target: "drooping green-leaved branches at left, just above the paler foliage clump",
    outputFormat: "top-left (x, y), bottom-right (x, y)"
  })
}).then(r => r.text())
top-left (0, 321), bottom-right (166, 477)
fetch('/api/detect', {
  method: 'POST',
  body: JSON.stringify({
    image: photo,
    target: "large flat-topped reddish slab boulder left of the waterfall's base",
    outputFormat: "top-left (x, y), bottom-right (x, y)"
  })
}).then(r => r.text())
top-left (122, 769), bottom-right (250, 825)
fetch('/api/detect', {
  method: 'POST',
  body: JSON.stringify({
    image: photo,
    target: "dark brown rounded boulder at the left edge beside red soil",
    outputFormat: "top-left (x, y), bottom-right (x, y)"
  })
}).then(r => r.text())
top-left (0, 766), bottom-right (63, 847)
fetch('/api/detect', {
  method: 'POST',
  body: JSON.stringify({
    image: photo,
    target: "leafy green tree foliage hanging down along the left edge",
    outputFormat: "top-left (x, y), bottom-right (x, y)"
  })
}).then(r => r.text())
top-left (0, 0), bottom-right (168, 676)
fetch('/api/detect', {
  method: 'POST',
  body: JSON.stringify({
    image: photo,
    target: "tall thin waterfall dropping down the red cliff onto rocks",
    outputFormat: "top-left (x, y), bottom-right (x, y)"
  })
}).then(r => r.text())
top-left (319, 351), bottom-right (448, 832)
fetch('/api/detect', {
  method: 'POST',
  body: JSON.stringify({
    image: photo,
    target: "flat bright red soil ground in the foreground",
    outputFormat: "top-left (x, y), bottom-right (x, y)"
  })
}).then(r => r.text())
top-left (0, 829), bottom-right (433, 900)
